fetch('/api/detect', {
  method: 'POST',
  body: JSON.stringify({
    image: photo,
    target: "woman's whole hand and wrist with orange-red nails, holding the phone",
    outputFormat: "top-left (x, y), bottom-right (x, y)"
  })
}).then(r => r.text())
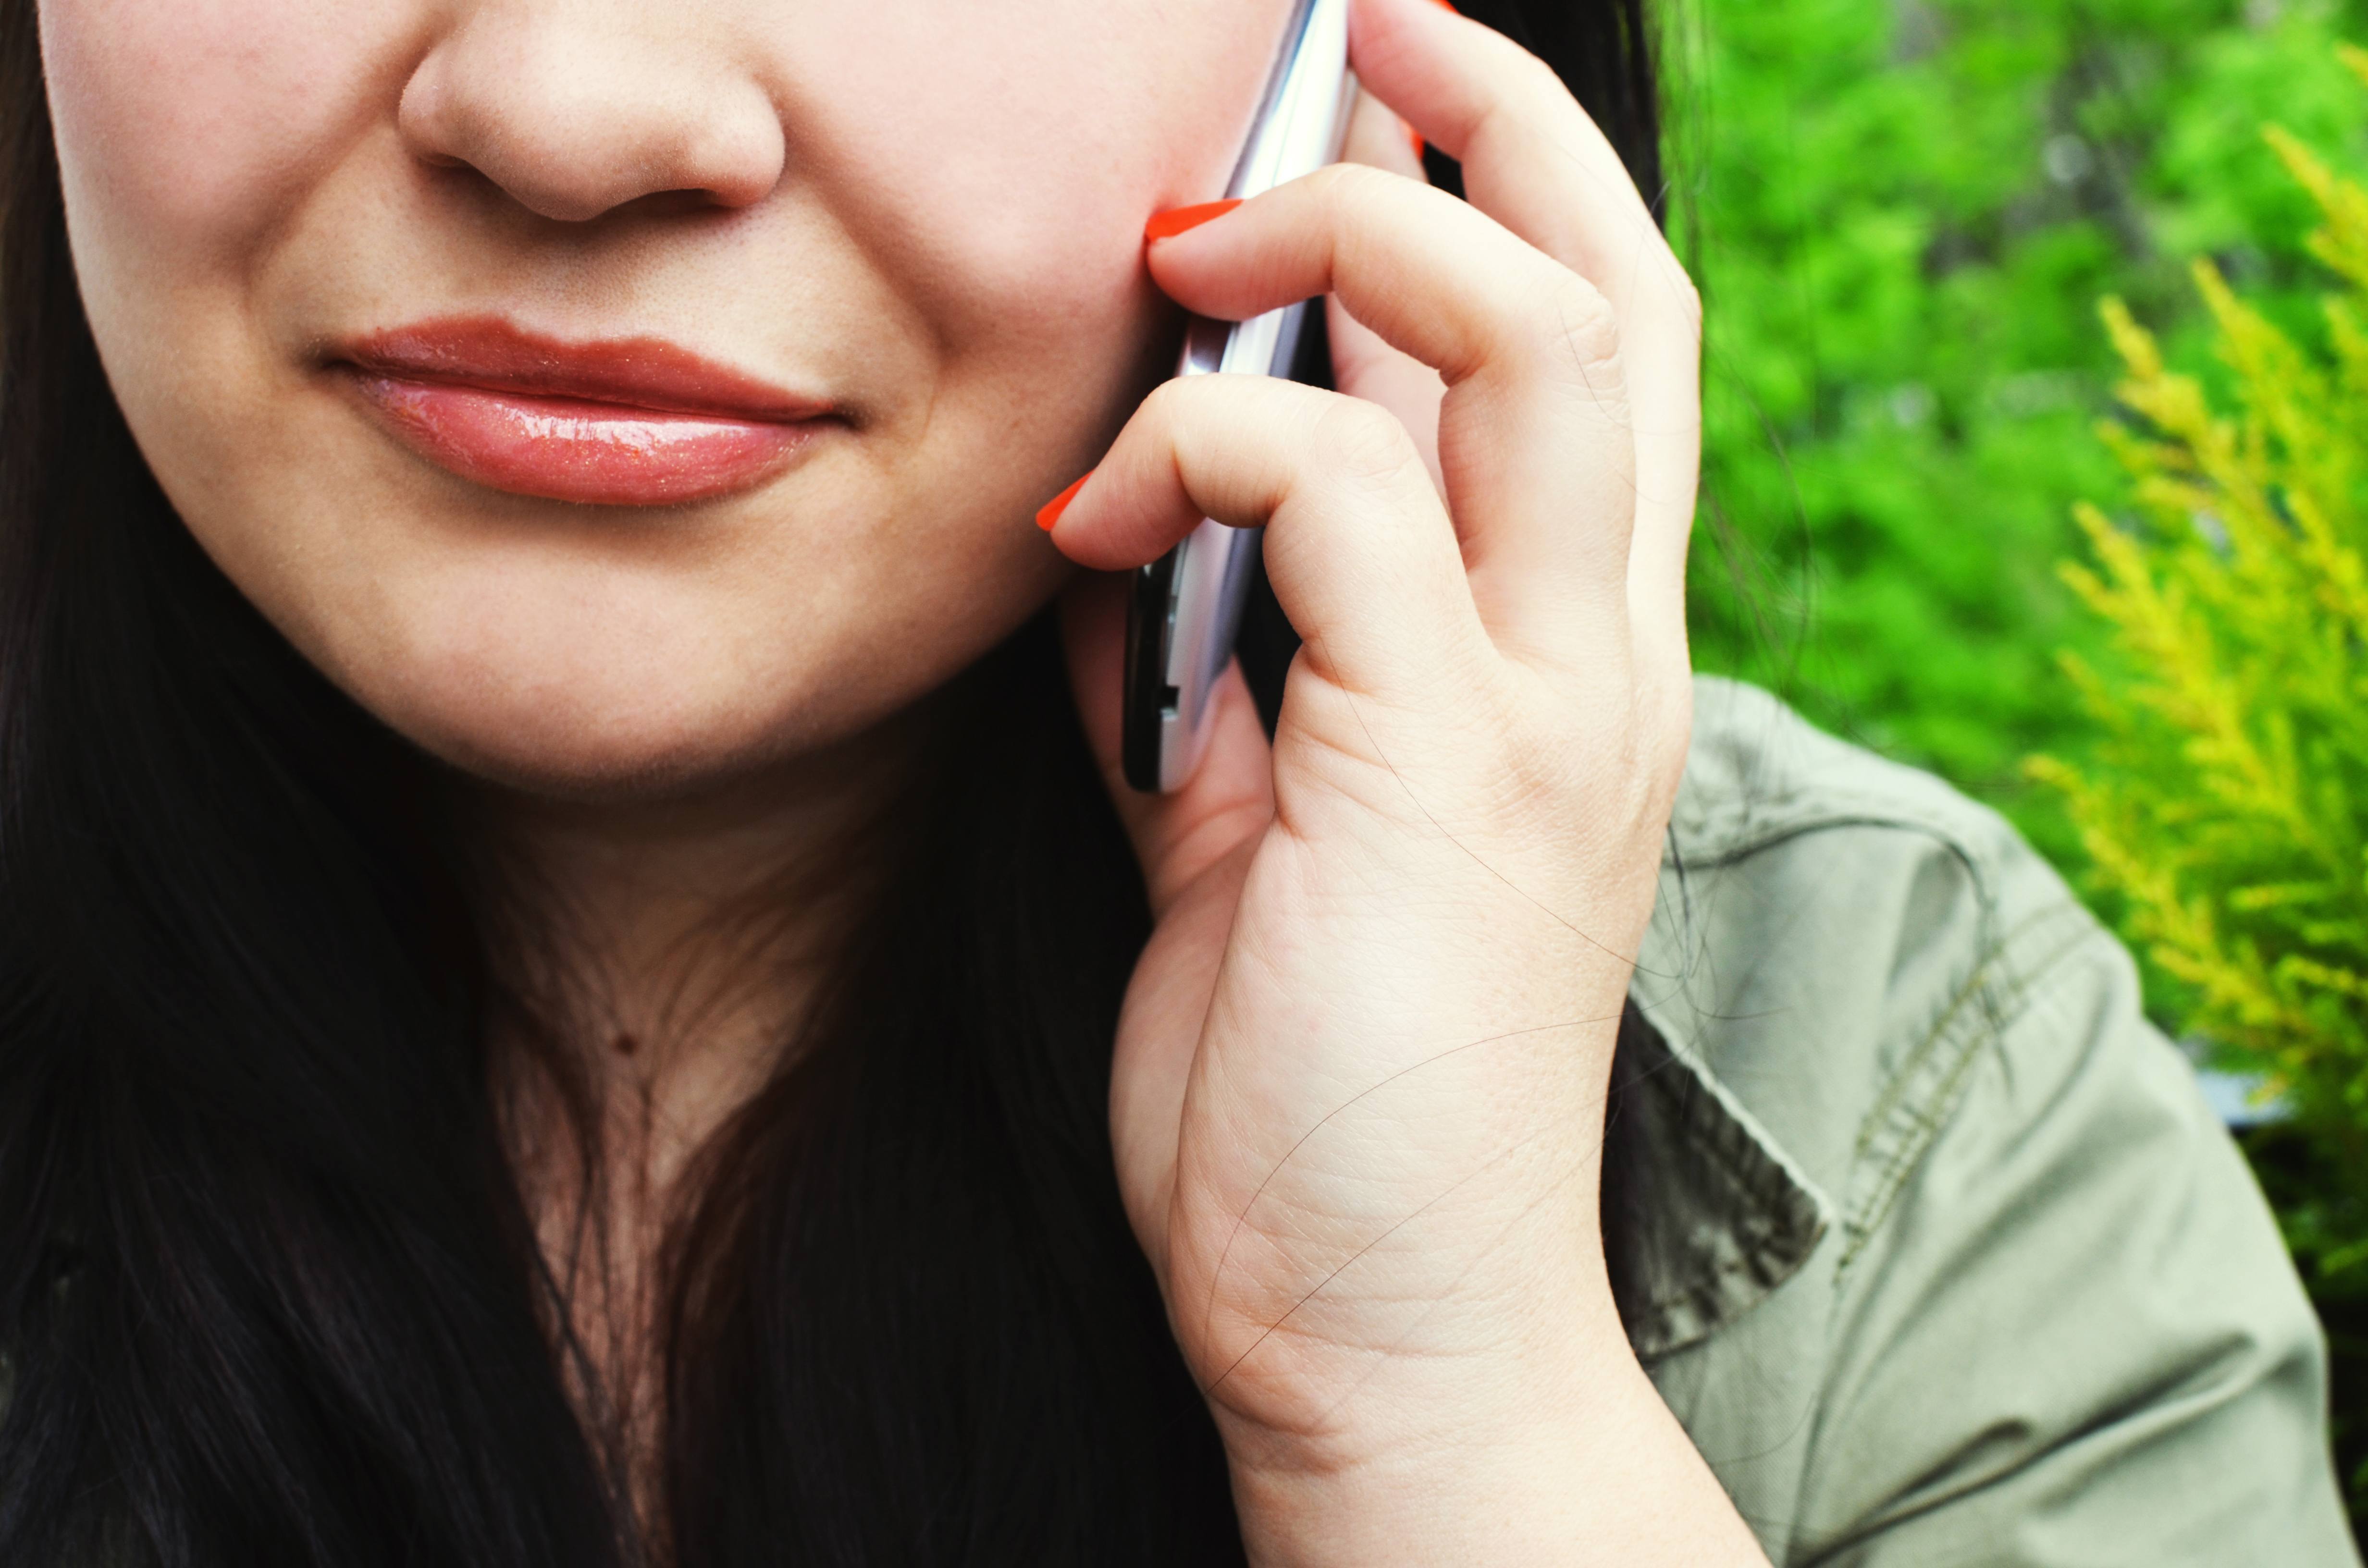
top-left (1054, 0), bottom-right (1755, 1563)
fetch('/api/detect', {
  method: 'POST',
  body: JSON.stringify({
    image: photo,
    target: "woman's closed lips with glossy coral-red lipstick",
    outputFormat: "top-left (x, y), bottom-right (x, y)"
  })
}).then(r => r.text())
top-left (334, 318), bottom-right (834, 507)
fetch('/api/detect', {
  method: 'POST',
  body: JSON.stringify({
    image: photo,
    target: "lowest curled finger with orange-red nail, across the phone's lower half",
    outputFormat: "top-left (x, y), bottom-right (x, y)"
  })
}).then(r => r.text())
top-left (1054, 377), bottom-right (1487, 706)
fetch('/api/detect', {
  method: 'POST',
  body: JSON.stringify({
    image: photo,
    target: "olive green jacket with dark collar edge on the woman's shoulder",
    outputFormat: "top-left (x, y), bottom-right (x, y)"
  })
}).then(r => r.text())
top-left (1615, 680), bottom-right (2358, 1568)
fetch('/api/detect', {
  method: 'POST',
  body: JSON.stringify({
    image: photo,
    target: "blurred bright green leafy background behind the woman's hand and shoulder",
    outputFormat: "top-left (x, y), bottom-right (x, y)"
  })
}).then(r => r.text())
top-left (1665, 0), bottom-right (2368, 874)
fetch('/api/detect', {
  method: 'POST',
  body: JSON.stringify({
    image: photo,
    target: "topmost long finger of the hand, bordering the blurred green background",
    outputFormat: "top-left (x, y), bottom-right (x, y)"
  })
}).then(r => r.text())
top-left (1350, 0), bottom-right (1702, 677)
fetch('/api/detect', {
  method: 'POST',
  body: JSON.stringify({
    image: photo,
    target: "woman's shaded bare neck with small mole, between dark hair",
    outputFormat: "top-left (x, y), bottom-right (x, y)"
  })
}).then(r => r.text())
top-left (478, 718), bottom-right (921, 1511)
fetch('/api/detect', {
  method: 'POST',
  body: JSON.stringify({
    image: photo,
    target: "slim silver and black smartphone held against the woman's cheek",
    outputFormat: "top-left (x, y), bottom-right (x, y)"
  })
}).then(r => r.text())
top-left (1120, 0), bottom-right (1357, 794)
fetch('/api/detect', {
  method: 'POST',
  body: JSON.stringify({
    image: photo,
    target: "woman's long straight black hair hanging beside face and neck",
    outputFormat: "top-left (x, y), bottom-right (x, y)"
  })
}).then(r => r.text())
top-left (0, 0), bottom-right (1660, 1568)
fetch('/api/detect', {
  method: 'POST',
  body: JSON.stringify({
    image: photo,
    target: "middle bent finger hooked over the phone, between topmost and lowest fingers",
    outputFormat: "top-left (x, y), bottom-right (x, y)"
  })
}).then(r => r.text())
top-left (1148, 163), bottom-right (1636, 665)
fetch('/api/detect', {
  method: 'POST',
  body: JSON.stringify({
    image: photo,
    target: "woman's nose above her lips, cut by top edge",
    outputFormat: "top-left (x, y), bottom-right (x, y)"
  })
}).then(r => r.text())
top-left (398, 0), bottom-right (786, 222)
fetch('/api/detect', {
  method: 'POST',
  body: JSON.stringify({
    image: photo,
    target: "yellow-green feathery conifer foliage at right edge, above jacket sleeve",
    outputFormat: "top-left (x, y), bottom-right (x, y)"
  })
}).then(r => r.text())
top-left (2029, 50), bottom-right (2368, 1293)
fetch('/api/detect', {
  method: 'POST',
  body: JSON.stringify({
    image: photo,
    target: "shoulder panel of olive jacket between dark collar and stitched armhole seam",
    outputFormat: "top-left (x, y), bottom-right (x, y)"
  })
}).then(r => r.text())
top-left (1639, 677), bottom-right (2129, 1239)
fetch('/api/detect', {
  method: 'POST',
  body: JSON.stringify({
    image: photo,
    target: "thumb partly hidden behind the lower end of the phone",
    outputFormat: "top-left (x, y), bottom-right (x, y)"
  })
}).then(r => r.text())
top-left (1061, 571), bottom-right (1274, 919)
